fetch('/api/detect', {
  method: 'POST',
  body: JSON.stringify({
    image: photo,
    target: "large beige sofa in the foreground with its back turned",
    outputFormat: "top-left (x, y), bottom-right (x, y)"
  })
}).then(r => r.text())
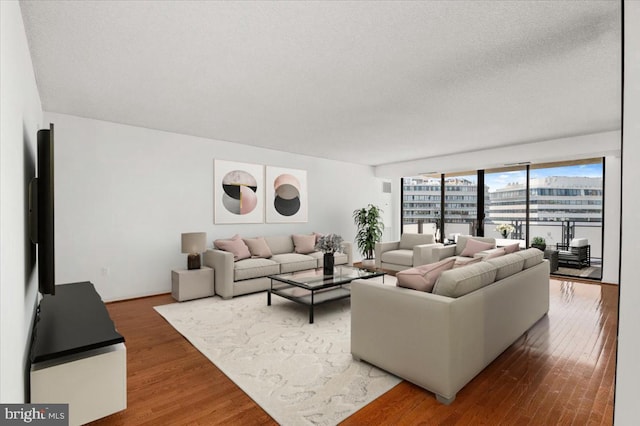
top-left (351, 249), bottom-right (549, 404)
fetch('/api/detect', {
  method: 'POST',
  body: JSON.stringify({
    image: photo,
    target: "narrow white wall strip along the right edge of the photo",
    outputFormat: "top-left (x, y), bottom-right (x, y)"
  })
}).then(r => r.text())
top-left (614, 1), bottom-right (640, 426)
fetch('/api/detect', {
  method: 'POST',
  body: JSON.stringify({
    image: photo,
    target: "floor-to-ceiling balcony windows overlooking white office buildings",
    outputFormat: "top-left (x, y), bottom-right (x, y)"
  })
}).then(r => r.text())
top-left (402, 158), bottom-right (604, 279)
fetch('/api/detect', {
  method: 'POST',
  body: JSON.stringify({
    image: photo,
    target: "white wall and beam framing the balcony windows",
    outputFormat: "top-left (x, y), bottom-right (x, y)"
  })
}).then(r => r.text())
top-left (375, 131), bottom-right (621, 284)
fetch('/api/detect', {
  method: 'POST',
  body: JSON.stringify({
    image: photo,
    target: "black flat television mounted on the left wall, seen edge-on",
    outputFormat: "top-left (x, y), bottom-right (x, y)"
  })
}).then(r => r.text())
top-left (29, 123), bottom-right (56, 295)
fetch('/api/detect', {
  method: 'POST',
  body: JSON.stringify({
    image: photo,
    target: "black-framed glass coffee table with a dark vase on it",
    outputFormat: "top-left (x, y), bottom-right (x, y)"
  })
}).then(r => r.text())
top-left (267, 265), bottom-right (384, 324)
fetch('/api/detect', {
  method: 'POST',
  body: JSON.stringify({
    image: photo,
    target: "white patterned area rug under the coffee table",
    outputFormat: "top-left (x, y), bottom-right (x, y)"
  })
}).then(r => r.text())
top-left (155, 284), bottom-right (400, 425)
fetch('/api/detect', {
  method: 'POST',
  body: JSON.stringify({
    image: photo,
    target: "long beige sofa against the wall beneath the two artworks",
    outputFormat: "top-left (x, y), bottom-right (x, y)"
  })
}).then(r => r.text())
top-left (203, 235), bottom-right (353, 299)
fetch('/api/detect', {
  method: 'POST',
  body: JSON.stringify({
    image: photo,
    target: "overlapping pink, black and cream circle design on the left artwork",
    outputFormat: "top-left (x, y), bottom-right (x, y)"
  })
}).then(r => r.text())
top-left (222, 170), bottom-right (258, 215)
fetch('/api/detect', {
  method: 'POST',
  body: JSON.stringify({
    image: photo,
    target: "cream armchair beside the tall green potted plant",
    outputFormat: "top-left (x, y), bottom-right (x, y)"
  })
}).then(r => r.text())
top-left (375, 233), bottom-right (442, 271)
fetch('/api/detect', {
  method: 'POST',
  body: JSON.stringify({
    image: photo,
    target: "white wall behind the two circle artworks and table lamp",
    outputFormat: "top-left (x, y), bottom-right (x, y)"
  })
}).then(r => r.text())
top-left (45, 112), bottom-right (383, 301)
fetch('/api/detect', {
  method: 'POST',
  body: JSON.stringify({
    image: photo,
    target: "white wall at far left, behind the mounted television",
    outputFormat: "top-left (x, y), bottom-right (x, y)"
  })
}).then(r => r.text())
top-left (0, 1), bottom-right (42, 403)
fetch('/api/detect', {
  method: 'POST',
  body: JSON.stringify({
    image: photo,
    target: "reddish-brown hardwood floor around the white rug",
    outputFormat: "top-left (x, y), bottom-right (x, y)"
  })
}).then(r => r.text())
top-left (92, 279), bottom-right (618, 425)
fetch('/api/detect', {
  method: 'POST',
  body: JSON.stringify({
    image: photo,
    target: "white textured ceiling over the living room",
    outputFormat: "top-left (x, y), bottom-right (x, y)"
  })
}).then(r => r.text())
top-left (21, 1), bottom-right (621, 165)
